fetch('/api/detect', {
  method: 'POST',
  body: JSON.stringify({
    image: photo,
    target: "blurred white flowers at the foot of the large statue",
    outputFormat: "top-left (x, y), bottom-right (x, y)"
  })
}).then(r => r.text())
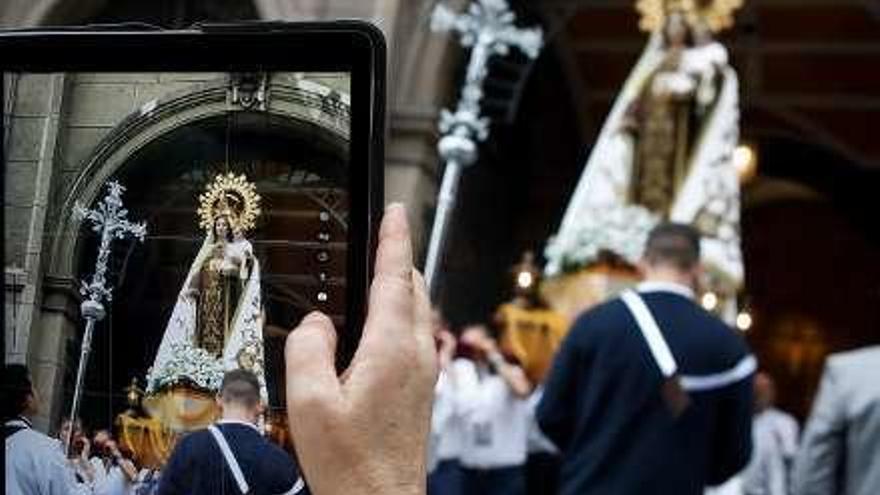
top-left (544, 205), bottom-right (658, 273)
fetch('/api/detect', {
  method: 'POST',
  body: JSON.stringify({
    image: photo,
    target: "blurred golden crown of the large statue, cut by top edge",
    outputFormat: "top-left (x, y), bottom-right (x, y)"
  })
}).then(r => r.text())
top-left (636, 0), bottom-right (744, 33)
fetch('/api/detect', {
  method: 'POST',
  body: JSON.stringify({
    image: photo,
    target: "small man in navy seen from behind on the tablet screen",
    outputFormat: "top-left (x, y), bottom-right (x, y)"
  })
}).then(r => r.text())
top-left (159, 370), bottom-right (307, 495)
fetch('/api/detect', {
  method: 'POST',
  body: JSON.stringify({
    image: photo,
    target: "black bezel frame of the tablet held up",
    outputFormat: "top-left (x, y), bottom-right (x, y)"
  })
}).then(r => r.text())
top-left (0, 21), bottom-right (386, 370)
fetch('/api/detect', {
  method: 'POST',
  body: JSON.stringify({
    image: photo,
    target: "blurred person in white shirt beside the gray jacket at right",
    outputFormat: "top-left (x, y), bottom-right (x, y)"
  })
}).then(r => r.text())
top-left (742, 373), bottom-right (800, 495)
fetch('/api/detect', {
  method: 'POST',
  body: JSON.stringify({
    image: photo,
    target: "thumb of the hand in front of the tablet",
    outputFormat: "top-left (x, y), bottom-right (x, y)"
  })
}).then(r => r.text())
top-left (284, 311), bottom-right (340, 418)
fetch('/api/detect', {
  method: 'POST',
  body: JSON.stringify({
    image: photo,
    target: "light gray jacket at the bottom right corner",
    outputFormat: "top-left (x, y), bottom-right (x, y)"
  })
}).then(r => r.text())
top-left (793, 346), bottom-right (880, 495)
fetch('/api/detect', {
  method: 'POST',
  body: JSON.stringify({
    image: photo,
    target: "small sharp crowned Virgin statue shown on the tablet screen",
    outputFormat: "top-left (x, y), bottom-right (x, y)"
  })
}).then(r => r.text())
top-left (145, 173), bottom-right (267, 429)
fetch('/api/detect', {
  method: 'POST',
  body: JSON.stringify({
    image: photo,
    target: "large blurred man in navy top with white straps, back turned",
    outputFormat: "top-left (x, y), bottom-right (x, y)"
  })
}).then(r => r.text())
top-left (537, 223), bottom-right (756, 495)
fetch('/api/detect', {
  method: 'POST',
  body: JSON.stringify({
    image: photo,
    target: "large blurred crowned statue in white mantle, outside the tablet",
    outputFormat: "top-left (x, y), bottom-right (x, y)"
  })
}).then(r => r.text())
top-left (545, 0), bottom-right (743, 322)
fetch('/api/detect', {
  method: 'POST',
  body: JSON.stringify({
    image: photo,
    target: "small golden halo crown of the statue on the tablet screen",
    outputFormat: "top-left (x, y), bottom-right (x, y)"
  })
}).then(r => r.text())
top-left (198, 172), bottom-right (261, 232)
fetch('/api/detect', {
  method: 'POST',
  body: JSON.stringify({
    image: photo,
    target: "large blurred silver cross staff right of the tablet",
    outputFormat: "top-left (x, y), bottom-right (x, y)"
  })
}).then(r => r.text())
top-left (425, 0), bottom-right (544, 295)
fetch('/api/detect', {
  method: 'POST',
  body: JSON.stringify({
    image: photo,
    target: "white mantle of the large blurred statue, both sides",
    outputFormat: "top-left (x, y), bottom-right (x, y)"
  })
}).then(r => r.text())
top-left (545, 30), bottom-right (743, 306)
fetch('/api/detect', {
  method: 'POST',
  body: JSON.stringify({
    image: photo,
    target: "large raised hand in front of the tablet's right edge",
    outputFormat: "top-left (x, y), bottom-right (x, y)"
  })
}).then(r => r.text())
top-left (285, 205), bottom-right (437, 495)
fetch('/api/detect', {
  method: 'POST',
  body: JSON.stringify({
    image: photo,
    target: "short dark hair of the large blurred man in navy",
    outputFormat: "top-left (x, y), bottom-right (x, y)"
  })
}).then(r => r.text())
top-left (645, 222), bottom-right (700, 271)
